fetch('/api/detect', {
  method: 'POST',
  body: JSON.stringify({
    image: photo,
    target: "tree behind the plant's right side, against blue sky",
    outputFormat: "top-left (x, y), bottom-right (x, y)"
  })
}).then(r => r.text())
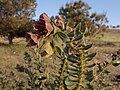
top-left (59, 0), bottom-right (108, 36)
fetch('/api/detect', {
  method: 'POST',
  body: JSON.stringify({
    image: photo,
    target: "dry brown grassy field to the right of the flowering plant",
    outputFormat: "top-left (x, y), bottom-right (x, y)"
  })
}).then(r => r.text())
top-left (92, 29), bottom-right (120, 74)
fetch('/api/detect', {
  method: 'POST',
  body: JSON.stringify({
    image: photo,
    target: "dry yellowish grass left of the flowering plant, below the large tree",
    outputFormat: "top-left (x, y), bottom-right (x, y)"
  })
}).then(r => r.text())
top-left (0, 38), bottom-right (26, 74)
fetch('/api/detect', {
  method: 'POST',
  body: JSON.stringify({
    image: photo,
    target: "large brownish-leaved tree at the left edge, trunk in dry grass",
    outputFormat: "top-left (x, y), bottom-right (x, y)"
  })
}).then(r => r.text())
top-left (0, 0), bottom-right (36, 44)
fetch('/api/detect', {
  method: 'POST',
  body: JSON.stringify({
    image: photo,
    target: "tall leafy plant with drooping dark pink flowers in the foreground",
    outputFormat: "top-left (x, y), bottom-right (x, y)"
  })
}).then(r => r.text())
top-left (17, 13), bottom-right (119, 90)
